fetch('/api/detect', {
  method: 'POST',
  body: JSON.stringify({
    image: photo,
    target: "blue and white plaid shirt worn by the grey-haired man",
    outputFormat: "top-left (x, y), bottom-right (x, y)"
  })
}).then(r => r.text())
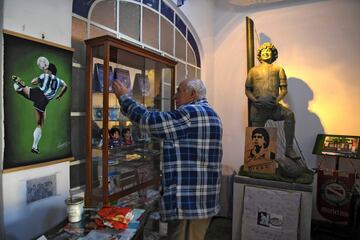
top-left (120, 95), bottom-right (222, 221)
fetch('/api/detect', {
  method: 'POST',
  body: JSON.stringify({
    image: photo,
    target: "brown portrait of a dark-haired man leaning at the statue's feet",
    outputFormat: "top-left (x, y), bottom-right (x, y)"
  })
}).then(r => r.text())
top-left (244, 127), bottom-right (277, 173)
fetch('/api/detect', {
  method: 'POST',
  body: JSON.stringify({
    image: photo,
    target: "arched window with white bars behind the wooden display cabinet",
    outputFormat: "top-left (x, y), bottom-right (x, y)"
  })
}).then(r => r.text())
top-left (70, 0), bottom-right (201, 188)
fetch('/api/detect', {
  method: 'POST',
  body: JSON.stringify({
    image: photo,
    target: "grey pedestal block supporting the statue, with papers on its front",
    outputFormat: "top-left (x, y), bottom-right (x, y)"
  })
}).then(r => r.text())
top-left (232, 176), bottom-right (313, 240)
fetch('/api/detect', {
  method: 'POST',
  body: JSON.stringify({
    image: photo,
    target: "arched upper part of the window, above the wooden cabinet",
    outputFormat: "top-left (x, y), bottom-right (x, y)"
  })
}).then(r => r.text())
top-left (72, 0), bottom-right (201, 84)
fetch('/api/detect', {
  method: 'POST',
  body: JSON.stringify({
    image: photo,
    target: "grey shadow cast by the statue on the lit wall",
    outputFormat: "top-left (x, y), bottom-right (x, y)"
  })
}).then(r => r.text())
top-left (285, 77), bottom-right (324, 168)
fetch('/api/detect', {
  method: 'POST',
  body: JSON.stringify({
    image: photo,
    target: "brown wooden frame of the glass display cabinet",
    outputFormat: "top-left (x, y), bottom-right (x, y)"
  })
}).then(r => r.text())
top-left (85, 35), bottom-right (176, 206)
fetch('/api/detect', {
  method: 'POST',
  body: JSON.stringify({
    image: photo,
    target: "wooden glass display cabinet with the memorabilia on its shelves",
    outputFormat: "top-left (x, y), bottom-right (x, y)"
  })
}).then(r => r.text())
top-left (85, 36), bottom-right (176, 206)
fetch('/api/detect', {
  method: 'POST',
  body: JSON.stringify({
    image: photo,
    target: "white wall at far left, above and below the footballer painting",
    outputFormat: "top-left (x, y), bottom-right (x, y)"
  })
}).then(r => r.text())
top-left (0, 0), bottom-right (72, 240)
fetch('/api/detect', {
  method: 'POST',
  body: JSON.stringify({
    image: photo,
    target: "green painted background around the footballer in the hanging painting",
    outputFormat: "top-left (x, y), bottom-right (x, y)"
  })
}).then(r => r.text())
top-left (3, 34), bottom-right (72, 169)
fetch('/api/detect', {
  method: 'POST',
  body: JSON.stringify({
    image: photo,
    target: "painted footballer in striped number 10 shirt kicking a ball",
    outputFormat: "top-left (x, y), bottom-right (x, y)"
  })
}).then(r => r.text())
top-left (11, 57), bottom-right (67, 154)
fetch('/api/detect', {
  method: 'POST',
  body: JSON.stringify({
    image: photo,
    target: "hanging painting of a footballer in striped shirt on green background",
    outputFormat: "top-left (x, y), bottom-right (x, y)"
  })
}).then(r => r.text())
top-left (3, 30), bottom-right (73, 169)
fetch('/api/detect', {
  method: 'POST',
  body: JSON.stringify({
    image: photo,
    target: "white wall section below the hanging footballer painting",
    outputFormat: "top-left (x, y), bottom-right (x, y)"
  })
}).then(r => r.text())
top-left (3, 162), bottom-right (70, 240)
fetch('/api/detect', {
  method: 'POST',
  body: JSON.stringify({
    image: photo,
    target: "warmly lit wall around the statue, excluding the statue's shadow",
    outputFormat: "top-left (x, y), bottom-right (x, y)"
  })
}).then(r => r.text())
top-left (182, 0), bottom-right (360, 221)
